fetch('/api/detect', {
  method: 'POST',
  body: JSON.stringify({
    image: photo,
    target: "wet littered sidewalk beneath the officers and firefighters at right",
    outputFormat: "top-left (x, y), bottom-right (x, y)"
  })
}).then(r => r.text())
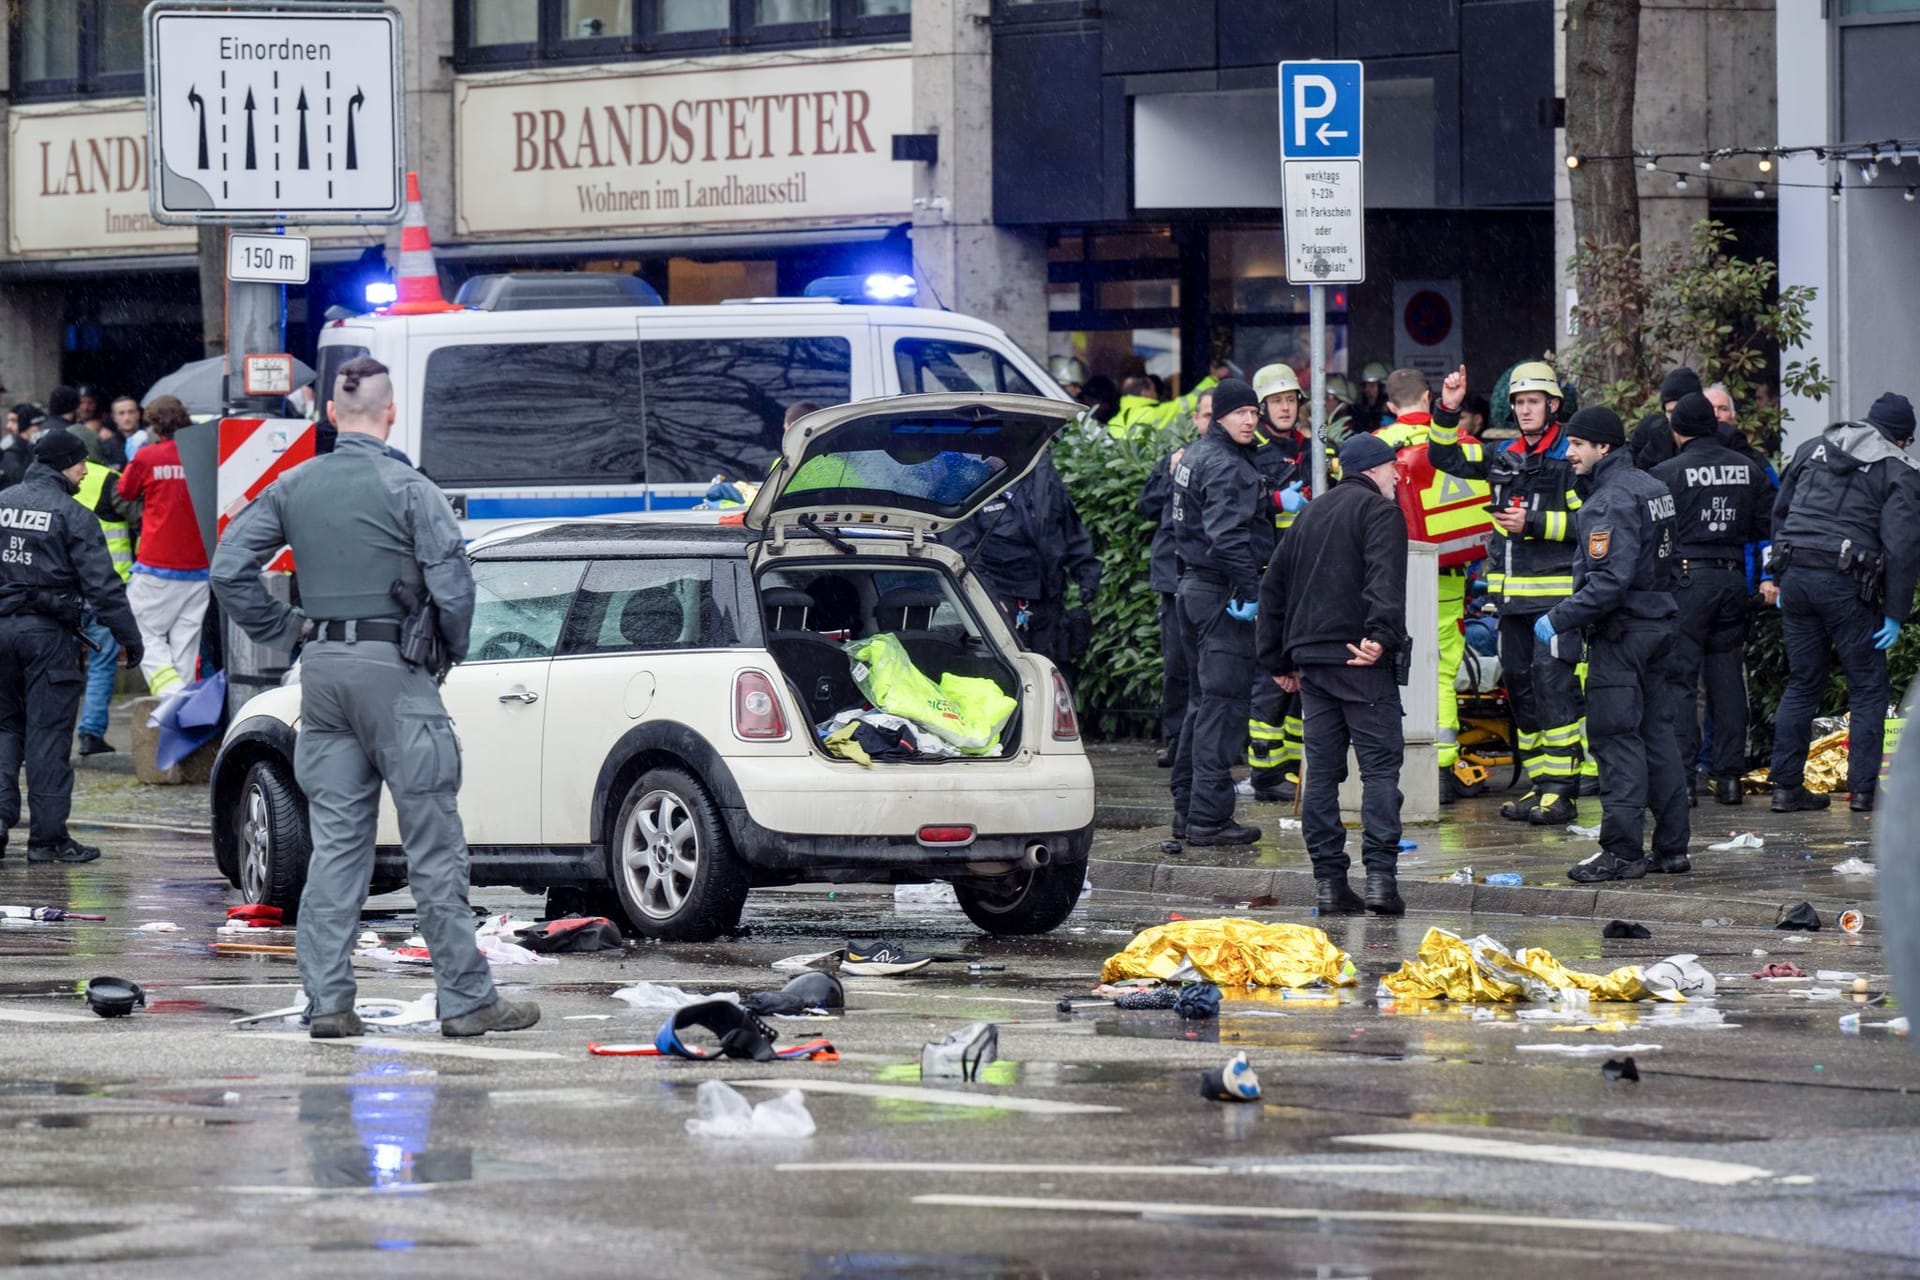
top-left (1087, 745), bottom-right (1878, 929)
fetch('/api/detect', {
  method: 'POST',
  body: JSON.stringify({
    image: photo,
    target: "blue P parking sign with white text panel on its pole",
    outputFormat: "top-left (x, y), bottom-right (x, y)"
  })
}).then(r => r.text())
top-left (1281, 61), bottom-right (1367, 493)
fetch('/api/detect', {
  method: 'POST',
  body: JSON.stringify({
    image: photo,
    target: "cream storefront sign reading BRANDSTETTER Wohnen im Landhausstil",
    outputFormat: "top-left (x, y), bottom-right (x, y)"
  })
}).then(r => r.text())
top-left (453, 56), bottom-right (914, 236)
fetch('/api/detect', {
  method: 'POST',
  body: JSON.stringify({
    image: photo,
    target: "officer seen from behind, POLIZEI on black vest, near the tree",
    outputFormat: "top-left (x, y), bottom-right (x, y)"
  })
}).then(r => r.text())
top-left (1647, 391), bottom-right (1774, 804)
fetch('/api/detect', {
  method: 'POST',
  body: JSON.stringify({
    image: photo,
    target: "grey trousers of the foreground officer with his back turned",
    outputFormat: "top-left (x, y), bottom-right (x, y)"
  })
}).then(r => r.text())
top-left (294, 641), bottom-right (495, 1019)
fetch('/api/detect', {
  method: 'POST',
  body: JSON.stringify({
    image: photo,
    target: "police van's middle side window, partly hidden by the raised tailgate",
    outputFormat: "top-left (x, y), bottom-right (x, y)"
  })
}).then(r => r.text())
top-left (639, 338), bottom-right (852, 484)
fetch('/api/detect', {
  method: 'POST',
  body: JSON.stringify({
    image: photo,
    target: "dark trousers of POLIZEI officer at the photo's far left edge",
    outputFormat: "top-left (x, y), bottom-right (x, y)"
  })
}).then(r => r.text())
top-left (0, 614), bottom-right (86, 846)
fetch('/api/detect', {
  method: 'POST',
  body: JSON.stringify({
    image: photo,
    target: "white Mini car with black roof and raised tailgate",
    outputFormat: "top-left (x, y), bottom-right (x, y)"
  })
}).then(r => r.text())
top-left (213, 395), bottom-right (1094, 938)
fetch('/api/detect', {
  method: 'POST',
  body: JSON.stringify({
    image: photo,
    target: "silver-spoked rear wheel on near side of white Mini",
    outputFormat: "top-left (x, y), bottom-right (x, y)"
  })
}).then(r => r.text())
top-left (607, 770), bottom-right (749, 942)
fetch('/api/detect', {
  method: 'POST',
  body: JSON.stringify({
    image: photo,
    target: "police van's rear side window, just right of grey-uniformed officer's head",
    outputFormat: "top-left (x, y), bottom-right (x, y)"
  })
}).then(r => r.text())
top-left (420, 342), bottom-right (647, 486)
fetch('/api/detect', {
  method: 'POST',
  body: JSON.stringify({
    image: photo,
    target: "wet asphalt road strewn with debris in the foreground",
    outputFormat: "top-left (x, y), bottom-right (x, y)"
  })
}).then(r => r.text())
top-left (0, 833), bottom-right (1920, 1278)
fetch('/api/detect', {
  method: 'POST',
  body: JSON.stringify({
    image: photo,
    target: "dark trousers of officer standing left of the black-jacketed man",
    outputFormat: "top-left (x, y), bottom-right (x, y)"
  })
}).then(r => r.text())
top-left (1173, 578), bottom-right (1254, 829)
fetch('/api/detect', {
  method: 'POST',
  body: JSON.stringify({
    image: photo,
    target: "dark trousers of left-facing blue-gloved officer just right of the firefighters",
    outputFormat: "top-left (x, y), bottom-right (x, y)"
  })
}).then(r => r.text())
top-left (1586, 620), bottom-right (1692, 862)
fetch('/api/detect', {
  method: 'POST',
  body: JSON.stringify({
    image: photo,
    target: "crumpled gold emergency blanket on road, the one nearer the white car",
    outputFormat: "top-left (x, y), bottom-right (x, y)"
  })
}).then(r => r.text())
top-left (1100, 917), bottom-right (1354, 986)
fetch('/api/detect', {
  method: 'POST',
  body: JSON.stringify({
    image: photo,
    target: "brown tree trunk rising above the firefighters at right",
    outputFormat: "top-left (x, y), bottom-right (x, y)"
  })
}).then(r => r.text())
top-left (1567, 0), bottom-right (1640, 382)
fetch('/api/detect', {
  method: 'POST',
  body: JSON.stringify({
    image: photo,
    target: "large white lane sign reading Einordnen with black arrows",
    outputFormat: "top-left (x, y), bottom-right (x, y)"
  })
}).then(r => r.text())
top-left (146, 0), bottom-right (405, 223)
